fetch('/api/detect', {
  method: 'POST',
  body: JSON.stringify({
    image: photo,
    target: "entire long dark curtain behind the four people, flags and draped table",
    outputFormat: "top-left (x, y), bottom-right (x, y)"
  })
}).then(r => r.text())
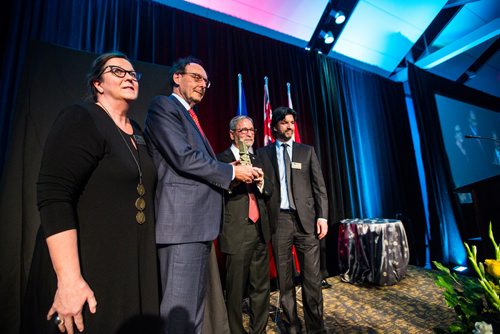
top-left (0, 0), bottom-right (425, 333)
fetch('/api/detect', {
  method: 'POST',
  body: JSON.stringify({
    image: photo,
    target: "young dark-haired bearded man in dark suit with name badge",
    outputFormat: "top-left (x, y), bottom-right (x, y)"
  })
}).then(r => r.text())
top-left (257, 107), bottom-right (328, 333)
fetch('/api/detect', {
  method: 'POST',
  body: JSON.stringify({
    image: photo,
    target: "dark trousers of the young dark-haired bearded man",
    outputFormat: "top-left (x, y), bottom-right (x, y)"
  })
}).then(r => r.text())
top-left (272, 212), bottom-right (324, 333)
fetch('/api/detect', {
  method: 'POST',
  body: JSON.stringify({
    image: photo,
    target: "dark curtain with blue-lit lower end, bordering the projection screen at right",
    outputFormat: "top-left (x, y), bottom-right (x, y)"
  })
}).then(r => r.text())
top-left (408, 64), bottom-right (500, 264)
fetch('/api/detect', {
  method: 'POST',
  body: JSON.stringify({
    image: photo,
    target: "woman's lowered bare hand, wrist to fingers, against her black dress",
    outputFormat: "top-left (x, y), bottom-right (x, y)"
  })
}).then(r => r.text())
top-left (47, 276), bottom-right (97, 334)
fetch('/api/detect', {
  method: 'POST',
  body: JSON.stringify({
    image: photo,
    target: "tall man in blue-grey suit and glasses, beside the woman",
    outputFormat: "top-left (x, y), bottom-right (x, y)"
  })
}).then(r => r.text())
top-left (145, 58), bottom-right (258, 333)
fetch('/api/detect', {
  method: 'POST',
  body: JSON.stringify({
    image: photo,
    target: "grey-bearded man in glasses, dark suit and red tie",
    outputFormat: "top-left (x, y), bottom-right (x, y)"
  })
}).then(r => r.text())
top-left (217, 116), bottom-right (272, 334)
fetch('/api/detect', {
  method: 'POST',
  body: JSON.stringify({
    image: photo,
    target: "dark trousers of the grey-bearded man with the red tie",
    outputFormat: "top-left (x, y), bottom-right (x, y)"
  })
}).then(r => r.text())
top-left (226, 224), bottom-right (270, 334)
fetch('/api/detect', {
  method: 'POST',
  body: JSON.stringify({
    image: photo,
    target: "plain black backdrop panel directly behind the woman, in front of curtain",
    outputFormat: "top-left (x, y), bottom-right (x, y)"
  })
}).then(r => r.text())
top-left (0, 42), bottom-right (170, 333)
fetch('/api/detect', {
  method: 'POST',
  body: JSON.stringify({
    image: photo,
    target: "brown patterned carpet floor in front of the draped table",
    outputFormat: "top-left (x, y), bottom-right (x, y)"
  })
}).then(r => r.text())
top-left (245, 266), bottom-right (455, 333)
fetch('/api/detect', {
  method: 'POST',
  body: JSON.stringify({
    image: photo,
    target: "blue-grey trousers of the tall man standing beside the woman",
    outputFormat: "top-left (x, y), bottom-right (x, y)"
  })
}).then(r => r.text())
top-left (158, 241), bottom-right (212, 334)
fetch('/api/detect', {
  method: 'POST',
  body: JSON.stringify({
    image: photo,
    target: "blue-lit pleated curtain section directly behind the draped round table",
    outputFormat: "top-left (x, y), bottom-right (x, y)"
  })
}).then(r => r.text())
top-left (307, 57), bottom-right (426, 270)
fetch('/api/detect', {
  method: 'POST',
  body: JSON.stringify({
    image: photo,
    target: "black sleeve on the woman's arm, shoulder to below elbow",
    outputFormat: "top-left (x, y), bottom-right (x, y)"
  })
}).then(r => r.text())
top-left (37, 105), bottom-right (105, 237)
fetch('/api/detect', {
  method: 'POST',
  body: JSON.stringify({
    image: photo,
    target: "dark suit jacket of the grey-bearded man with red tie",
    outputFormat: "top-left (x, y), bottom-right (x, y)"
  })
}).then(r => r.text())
top-left (217, 148), bottom-right (272, 254)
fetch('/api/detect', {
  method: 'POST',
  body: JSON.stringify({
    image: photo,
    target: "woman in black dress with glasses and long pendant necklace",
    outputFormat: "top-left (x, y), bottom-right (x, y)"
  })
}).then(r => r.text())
top-left (22, 53), bottom-right (159, 333)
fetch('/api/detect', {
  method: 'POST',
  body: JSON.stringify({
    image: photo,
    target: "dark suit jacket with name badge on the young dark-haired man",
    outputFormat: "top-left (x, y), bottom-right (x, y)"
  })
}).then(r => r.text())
top-left (257, 142), bottom-right (328, 233)
